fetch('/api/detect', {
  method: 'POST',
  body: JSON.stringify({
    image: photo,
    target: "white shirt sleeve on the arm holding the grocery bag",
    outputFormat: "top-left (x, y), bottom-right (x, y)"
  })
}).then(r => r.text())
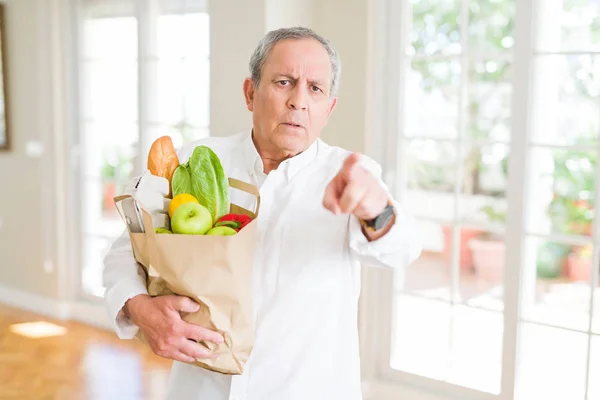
top-left (102, 230), bottom-right (148, 339)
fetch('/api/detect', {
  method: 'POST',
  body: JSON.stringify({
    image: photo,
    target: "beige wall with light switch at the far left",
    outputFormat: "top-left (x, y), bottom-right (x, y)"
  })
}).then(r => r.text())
top-left (0, 0), bottom-right (69, 310)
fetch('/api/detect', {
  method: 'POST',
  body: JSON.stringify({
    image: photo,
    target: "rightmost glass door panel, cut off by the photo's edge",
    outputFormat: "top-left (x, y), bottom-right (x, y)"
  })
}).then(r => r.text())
top-left (516, 0), bottom-right (600, 400)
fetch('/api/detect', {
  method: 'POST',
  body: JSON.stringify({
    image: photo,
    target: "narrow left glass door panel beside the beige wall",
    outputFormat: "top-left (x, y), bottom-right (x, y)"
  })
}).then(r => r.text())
top-left (79, 1), bottom-right (139, 296)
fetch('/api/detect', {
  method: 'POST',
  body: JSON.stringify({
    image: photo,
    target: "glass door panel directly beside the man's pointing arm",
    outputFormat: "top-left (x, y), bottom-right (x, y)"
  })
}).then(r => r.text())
top-left (390, 0), bottom-right (515, 394)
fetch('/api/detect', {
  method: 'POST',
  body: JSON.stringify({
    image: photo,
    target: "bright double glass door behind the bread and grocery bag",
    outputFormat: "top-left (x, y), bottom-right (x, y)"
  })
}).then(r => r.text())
top-left (79, 0), bottom-right (209, 296)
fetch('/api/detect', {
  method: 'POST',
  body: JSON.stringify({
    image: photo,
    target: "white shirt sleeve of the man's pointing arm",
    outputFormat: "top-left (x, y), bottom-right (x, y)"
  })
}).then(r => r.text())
top-left (349, 157), bottom-right (422, 269)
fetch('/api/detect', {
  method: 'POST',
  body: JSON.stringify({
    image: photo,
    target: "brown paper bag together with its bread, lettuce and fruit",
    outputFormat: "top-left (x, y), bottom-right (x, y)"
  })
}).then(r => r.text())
top-left (115, 136), bottom-right (260, 374)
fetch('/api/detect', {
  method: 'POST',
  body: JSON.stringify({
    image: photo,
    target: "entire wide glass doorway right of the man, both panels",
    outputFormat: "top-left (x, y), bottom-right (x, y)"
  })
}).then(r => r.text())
top-left (377, 0), bottom-right (600, 400)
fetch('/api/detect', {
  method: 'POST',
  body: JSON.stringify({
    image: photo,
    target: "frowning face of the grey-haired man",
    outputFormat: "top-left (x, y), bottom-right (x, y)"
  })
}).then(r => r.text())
top-left (244, 39), bottom-right (336, 155)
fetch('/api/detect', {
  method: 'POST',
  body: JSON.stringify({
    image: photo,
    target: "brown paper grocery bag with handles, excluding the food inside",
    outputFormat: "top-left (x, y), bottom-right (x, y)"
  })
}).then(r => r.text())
top-left (115, 178), bottom-right (260, 374)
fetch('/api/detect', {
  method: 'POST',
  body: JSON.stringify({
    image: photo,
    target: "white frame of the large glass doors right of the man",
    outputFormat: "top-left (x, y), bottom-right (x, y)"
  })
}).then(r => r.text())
top-left (361, 0), bottom-right (600, 400)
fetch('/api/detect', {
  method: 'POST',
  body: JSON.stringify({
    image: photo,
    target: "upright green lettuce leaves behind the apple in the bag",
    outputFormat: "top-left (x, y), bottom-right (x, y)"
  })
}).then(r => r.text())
top-left (172, 146), bottom-right (229, 222)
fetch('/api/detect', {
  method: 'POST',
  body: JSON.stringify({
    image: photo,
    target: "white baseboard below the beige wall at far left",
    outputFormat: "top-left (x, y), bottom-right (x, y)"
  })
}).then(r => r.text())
top-left (0, 285), bottom-right (71, 321)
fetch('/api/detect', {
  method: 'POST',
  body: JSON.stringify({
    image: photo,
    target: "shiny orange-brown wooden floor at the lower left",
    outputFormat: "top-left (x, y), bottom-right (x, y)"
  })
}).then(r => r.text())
top-left (0, 305), bottom-right (171, 400)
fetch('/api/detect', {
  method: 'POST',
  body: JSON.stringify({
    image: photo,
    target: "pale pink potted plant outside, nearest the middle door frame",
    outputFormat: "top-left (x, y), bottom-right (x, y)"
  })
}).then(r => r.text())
top-left (469, 205), bottom-right (506, 282)
